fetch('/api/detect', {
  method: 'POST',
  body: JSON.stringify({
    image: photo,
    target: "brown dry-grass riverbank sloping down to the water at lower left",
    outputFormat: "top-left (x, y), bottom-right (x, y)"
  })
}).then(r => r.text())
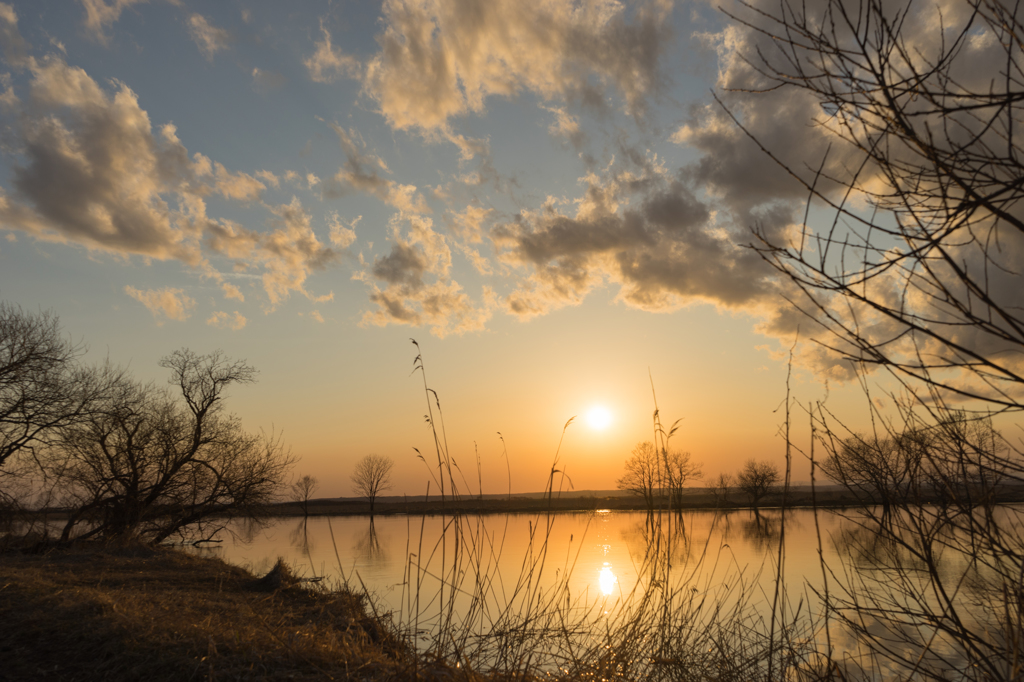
top-left (0, 546), bottom-right (472, 681)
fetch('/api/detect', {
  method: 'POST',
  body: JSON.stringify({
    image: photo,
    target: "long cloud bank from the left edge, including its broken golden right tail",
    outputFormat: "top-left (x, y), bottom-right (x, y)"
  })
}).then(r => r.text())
top-left (0, 43), bottom-right (337, 309)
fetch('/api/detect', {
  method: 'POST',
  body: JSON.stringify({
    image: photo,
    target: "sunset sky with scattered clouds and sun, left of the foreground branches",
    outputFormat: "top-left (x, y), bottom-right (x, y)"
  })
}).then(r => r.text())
top-left (0, 0), bottom-right (946, 496)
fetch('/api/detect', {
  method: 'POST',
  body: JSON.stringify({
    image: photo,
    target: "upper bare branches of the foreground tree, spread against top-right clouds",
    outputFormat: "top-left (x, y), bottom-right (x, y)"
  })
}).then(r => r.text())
top-left (737, 0), bottom-right (1024, 411)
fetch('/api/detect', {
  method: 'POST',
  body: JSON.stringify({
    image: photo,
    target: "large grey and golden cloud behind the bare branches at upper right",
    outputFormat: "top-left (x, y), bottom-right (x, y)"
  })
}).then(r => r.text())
top-left (672, 0), bottom-right (1024, 379)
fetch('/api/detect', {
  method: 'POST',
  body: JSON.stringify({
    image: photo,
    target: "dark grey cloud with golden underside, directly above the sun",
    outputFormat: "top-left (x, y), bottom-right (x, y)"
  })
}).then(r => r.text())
top-left (490, 155), bottom-right (772, 317)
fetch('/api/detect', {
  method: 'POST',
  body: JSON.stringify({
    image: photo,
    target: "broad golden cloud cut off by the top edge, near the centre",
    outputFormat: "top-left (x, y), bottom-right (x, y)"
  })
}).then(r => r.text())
top-left (362, 0), bottom-right (671, 133)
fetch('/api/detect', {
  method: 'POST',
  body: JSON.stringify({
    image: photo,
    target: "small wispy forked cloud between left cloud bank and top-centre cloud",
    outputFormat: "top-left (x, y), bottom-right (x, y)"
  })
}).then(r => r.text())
top-left (321, 124), bottom-right (430, 213)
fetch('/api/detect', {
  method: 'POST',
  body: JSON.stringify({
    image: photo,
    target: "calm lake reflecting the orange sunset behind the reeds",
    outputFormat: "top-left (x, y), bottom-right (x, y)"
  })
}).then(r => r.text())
top-left (195, 509), bottom-right (1019, 679)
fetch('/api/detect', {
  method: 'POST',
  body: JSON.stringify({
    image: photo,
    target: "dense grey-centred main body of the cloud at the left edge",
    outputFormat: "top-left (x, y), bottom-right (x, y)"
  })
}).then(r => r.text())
top-left (0, 56), bottom-right (200, 264)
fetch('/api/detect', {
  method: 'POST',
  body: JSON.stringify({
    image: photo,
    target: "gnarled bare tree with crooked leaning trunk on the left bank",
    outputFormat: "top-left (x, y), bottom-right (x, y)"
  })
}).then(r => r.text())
top-left (46, 349), bottom-right (293, 543)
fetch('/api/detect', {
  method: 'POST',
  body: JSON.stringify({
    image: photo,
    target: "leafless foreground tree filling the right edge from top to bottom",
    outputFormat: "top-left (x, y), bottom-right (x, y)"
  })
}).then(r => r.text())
top-left (734, 0), bottom-right (1024, 680)
